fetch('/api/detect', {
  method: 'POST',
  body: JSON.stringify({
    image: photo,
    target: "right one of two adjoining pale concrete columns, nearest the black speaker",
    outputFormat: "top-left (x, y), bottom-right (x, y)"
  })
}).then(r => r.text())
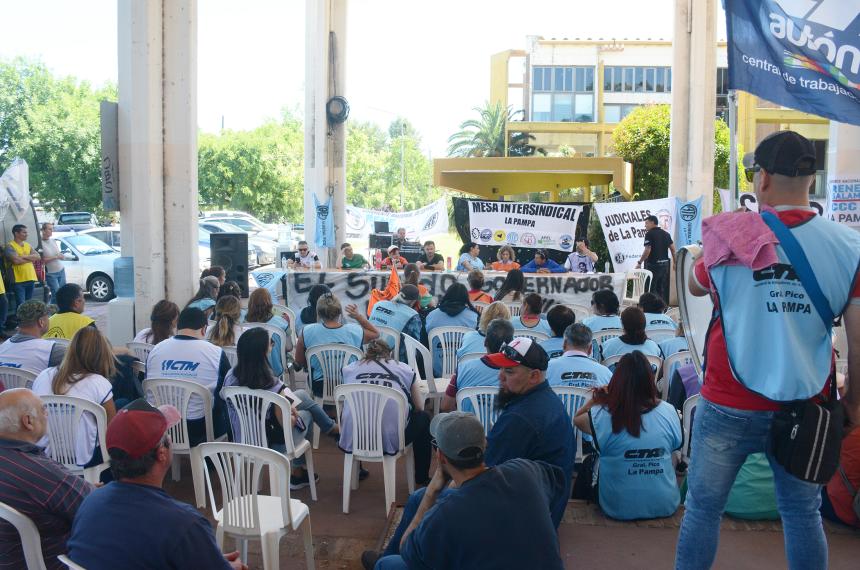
top-left (163, 0), bottom-right (199, 306)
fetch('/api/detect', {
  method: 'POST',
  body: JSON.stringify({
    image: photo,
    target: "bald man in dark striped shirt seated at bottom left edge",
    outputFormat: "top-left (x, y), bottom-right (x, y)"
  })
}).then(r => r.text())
top-left (0, 388), bottom-right (92, 569)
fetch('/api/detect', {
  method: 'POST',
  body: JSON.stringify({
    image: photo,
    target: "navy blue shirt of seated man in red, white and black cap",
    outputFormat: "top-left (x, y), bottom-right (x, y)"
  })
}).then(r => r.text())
top-left (485, 381), bottom-right (576, 527)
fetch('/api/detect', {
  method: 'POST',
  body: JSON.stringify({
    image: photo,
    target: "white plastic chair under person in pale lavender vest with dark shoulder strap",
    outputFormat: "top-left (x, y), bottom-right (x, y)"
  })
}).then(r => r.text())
top-left (335, 384), bottom-right (415, 516)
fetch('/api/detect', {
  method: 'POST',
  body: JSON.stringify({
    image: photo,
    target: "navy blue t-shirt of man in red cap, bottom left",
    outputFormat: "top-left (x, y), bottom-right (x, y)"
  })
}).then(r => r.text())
top-left (67, 481), bottom-right (230, 570)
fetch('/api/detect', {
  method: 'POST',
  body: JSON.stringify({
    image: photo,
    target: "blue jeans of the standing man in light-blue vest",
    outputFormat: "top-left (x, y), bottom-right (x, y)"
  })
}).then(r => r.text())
top-left (675, 398), bottom-right (827, 570)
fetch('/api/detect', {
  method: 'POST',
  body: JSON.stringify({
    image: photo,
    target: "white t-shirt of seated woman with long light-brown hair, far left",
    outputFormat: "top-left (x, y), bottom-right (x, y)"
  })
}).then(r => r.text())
top-left (33, 368), bottom-right (113, 466)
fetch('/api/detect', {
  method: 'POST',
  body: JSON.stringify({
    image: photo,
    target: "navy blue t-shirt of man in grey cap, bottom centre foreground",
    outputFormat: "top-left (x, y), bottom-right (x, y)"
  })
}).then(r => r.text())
top-left (400, 459), bottom-right (569, 569)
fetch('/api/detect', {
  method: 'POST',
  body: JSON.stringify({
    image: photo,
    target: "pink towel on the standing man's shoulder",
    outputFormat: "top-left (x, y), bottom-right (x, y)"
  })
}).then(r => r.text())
top-left (702, 212), bottom-right (779, 270)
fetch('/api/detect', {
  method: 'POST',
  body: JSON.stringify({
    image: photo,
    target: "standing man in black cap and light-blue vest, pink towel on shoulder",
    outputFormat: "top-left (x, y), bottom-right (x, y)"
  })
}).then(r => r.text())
top-left (676, 131), bottom-right (860, 569)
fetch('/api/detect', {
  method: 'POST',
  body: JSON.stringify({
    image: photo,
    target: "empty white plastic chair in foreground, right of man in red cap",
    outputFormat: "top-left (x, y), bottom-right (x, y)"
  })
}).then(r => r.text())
top-left (197, 443), bottom-right (314, 570)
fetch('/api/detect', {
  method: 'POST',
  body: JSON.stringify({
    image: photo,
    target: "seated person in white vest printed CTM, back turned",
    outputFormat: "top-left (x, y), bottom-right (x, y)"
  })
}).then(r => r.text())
top-left (146, 306), bottom-right (230, 446)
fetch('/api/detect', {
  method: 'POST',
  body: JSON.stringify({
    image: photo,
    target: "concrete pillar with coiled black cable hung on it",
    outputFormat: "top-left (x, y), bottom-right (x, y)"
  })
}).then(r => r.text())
top-left (305, 0), bottom-right (347, 267)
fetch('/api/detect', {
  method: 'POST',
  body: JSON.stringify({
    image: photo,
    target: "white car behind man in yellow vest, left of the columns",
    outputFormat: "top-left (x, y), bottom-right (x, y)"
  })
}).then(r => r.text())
top-left (54, 233), bottom-right (119, 302)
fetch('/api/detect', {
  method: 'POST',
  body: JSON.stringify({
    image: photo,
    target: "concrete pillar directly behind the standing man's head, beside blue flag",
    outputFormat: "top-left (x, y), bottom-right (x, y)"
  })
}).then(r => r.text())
top-left (669, 0), bottom-right (717, 216)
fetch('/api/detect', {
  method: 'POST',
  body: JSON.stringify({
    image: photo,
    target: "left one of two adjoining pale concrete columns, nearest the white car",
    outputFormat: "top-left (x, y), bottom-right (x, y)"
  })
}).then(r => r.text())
top-left (117, 0), bottom-right (165, 330)
